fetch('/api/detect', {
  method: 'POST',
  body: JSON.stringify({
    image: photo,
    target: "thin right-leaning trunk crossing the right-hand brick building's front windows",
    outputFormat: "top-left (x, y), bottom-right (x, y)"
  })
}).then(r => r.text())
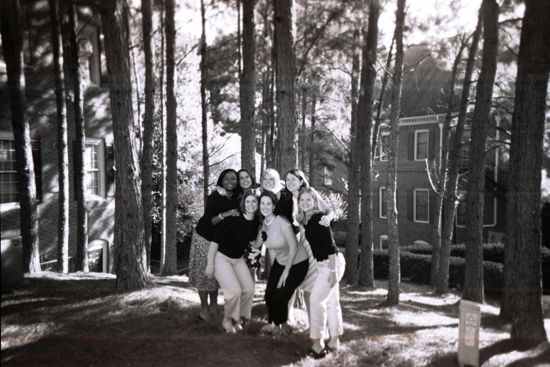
top-left (430, 41), bottom-right (466, 286)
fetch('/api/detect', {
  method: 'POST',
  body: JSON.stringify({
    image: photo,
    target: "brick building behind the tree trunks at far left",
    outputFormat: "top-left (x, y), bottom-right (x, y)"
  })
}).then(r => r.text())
top-left (0, 0), bottom-right (114, 270)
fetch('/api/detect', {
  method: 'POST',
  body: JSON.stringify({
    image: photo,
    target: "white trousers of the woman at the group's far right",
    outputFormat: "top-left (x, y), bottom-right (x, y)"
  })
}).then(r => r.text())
top-left (309, 253), bottom-right (346, 339)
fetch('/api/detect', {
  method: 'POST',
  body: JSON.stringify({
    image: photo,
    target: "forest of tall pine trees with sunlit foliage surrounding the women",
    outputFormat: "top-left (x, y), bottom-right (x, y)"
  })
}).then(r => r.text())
top-left (0, 0), bottom-right (550, 348)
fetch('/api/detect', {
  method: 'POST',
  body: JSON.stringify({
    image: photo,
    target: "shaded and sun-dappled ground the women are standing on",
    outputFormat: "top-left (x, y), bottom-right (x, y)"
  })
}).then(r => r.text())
top-left (1, 272), bottom-right (550, 367)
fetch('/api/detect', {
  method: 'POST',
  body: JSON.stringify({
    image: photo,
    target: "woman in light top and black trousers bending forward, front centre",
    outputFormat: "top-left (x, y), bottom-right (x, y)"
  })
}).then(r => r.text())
top-left (255, 190), bottom-right (308, 332)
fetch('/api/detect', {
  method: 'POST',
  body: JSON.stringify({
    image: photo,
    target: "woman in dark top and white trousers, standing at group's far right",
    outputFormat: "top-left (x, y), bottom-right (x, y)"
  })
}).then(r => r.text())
top-left (298, 188), bottom-right (345, 356)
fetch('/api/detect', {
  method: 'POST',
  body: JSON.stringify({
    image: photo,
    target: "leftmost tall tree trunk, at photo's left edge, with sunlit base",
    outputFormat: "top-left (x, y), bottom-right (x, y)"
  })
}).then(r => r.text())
top-left (0, 0), bottom-right (40, 273)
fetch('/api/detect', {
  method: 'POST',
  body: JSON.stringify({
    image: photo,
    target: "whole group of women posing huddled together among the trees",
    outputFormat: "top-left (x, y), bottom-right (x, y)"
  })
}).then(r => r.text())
top-left (189, 169), bottom-right (345, 357)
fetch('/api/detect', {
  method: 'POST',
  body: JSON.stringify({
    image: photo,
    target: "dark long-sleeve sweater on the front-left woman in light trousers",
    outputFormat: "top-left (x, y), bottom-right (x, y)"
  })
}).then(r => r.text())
top-left (211, 214), bottom-right (260, 259)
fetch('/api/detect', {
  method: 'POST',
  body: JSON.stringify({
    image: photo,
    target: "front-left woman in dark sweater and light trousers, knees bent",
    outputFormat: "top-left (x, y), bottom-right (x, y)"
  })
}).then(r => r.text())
top-left (206, 190), bottom-right (260, 333)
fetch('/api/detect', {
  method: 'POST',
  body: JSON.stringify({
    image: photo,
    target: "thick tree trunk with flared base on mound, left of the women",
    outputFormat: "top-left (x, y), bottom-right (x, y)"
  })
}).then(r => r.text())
top-left (101, 0), bottom-right (147, 291)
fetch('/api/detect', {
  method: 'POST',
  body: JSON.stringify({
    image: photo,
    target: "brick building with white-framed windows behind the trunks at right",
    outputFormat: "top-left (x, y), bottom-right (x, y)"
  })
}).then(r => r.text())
top-left (373, 114), bottom-right (506, 248)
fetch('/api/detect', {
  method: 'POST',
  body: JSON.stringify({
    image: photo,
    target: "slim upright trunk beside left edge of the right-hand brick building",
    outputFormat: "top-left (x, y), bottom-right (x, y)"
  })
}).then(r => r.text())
top-left (387, 0), bottom-right (405, 305)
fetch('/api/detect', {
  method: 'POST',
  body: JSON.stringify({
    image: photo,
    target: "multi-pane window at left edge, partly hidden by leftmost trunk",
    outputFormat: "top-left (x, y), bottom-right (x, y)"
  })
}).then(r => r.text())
top-left (0, 137), bottom-right (42, 204)
